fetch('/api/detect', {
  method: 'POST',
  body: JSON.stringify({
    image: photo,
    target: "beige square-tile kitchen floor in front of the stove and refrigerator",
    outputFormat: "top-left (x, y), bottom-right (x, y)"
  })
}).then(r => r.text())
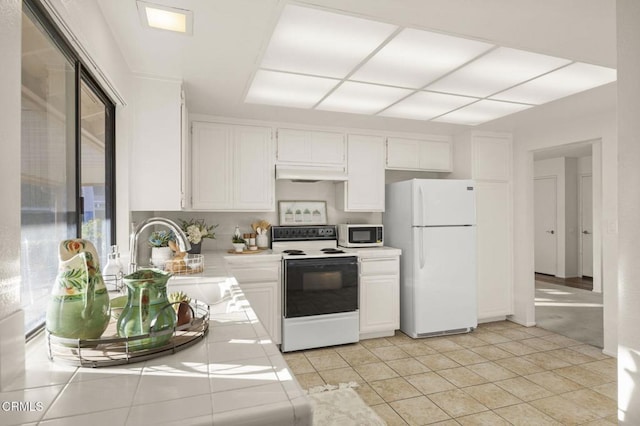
top-left (284, 321), bottom-right (617, 426)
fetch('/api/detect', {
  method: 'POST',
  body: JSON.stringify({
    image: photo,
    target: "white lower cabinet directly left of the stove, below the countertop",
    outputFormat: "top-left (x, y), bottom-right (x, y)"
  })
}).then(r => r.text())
top-left (225, 255), bottom-right (282, 344)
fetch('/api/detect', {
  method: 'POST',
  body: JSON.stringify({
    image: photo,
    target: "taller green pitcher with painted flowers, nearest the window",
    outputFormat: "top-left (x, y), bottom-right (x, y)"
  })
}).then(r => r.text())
top-left (46, 239), bottom-right (110, 339)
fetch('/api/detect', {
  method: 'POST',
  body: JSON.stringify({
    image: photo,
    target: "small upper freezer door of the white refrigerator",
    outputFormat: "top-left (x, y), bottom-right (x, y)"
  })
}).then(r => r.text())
top-left (413, 179), bottom-right (476, 226)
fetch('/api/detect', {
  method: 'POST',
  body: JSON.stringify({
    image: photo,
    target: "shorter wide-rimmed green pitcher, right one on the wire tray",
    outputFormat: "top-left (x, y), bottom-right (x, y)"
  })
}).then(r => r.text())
top-left (117, 269), bottom-right (176, 351)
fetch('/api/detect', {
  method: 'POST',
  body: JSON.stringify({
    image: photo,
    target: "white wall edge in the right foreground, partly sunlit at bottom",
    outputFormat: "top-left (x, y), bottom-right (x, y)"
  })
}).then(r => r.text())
top-left (616, 0), bottom-right (640, 425)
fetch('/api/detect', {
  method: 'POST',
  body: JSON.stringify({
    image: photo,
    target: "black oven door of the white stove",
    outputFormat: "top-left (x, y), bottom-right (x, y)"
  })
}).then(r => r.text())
top-left (283, 256), bottom-right (358, 318)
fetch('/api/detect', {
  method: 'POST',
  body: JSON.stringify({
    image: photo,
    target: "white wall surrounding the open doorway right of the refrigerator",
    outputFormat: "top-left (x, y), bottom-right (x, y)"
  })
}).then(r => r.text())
top-left (513, 110), bottom-right (618, 354)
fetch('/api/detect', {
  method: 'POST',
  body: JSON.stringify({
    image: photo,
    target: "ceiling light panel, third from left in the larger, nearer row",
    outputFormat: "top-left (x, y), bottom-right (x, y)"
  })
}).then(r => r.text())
top-left (428, 47), bottom-right (571, 97)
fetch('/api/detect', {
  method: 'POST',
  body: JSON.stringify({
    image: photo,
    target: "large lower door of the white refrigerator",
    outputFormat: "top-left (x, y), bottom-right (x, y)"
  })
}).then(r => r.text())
top-left (413, 226), bottom-right (478, 335)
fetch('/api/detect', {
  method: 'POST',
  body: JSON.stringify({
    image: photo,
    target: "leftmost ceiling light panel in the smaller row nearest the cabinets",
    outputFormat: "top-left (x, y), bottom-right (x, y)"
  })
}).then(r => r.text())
top-left (245, 70), bottom-right (340, 108)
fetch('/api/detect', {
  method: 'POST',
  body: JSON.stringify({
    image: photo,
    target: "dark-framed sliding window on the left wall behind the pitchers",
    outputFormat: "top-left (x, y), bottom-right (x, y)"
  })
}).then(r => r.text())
top-left (21, 0), bottom-right (115, 335)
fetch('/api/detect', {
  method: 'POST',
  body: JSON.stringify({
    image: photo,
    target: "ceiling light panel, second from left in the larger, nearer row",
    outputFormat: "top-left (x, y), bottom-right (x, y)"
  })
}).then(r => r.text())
top-left (350, 29), bottom-right (494, 89)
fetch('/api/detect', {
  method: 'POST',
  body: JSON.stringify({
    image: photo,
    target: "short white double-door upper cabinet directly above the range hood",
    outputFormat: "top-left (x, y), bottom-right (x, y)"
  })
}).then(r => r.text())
top-left (277, 129), bottom-right (345, 167)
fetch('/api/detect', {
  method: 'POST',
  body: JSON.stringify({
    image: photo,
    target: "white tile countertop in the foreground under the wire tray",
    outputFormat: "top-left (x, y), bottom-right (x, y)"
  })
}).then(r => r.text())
top-left (0, 250), bottom-right (312, 426)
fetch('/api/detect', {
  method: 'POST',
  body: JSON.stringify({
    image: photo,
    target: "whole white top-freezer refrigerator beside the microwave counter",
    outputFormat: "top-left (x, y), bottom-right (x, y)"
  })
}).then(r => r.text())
top-left (383, 179), bottom-right (478, 338)
